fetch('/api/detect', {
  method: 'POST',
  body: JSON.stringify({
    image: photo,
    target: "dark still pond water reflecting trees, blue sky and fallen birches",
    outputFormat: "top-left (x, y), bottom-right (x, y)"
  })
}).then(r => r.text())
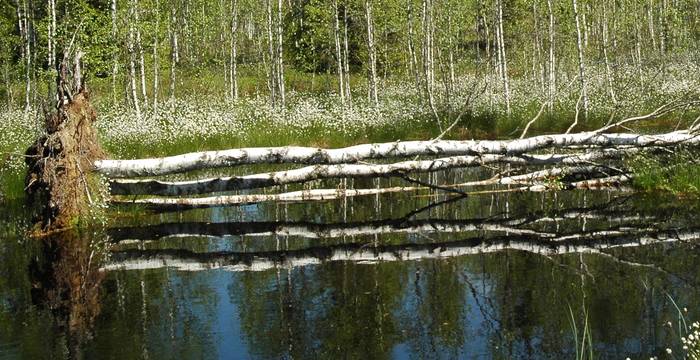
top-left (0, 174), bottom-right (700, 359)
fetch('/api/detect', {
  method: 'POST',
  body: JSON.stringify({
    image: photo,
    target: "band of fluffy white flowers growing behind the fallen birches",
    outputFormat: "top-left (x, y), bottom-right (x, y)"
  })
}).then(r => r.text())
top-left (0, 63), bottom-right (700, 187)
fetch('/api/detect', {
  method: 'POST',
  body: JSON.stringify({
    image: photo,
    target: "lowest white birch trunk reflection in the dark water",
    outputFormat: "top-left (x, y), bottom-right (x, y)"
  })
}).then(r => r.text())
top-left (102, 229), bottom-right (700, 271)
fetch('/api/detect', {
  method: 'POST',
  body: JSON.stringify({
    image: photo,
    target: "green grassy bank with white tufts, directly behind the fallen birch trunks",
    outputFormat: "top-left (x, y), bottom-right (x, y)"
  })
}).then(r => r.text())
top-left (0, 64), bottom-right (700, 197)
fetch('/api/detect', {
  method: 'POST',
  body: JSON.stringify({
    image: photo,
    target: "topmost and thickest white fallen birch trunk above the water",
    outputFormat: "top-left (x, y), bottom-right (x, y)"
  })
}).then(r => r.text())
top-left (95, 131), bottom-right (700, 178)
